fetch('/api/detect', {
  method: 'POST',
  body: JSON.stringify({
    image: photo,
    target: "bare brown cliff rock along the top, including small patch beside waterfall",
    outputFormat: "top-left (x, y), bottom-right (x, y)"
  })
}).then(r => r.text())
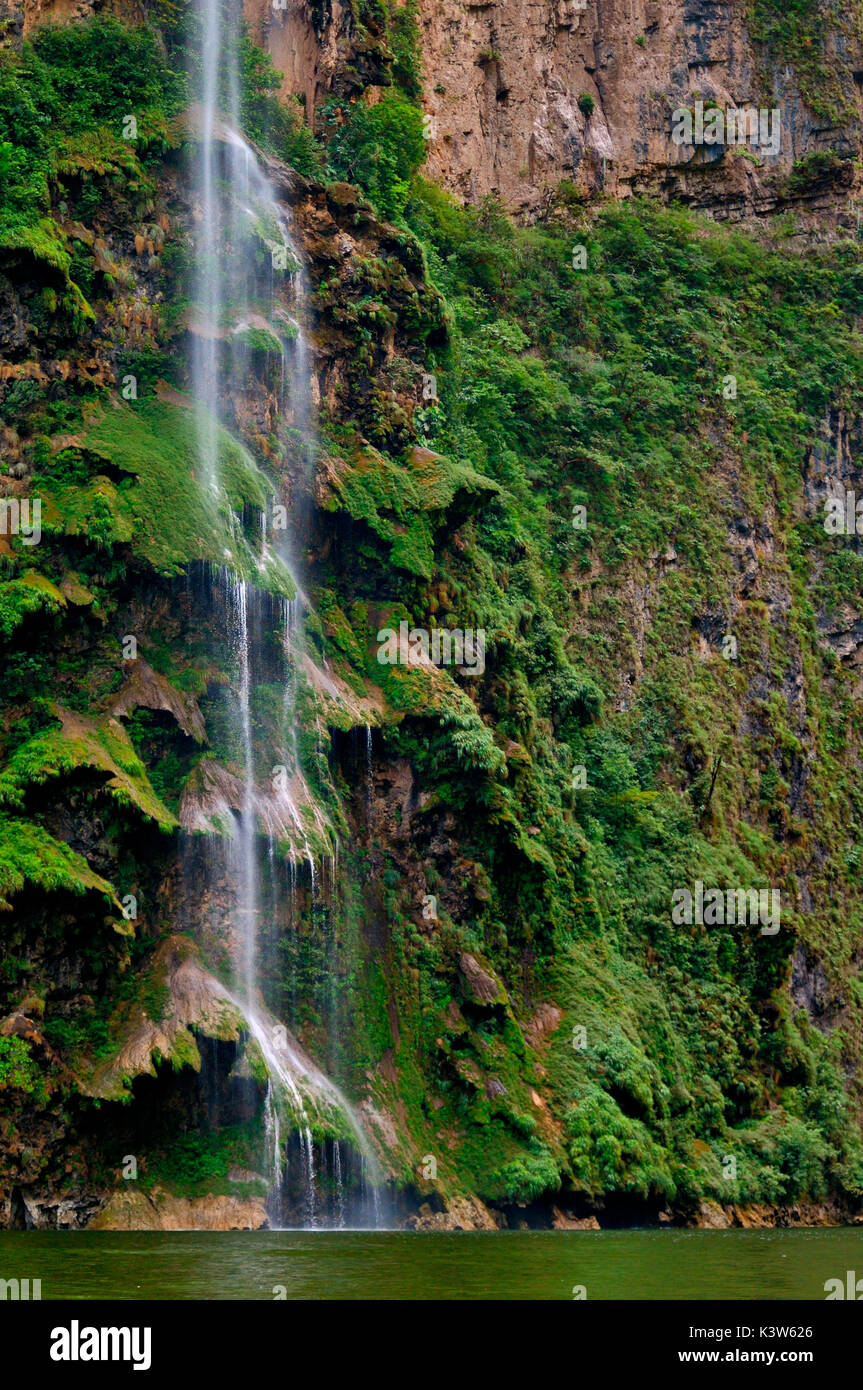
top-left (246, 0), bottom-right (863, 217)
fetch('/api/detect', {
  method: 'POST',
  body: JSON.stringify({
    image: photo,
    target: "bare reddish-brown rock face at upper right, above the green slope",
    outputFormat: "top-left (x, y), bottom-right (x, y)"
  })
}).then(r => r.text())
top-left (421, 0), bottom-right (860, 215)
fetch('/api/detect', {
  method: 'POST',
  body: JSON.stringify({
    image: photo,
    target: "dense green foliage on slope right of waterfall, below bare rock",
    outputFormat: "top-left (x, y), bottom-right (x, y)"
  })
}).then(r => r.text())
top-left (344, 183), bottom-right (863, 1201)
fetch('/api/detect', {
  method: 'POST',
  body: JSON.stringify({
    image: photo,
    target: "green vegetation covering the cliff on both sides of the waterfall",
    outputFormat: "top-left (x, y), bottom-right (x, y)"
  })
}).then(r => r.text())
top-left (0, 4), bottom-right (863, 1208)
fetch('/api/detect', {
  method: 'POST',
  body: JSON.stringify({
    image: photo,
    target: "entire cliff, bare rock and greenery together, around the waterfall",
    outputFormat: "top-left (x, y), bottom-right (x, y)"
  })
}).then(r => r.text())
top-left (0, 0), bottom-right (863, 1229)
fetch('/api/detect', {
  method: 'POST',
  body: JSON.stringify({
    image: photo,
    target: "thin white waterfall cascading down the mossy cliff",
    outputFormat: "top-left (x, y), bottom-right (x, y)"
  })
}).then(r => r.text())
top-left (186, 0), bottom-right (379, 1225)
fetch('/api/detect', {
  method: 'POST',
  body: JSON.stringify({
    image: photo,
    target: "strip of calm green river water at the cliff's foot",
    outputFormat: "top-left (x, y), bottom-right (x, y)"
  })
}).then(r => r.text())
top-left (0, 1229), bottom-right (863, 1300)
